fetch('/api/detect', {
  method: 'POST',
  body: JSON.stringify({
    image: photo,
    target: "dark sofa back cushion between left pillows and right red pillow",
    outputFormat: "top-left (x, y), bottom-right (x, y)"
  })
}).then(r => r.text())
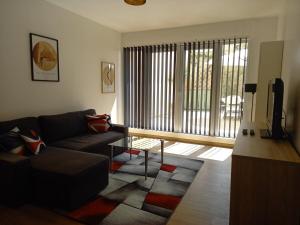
top-left (38, 109), bottom-right (96, 143)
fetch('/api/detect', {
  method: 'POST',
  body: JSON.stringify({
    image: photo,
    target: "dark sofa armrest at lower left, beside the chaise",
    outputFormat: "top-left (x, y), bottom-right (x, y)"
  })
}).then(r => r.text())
top-left (0, 152), bottom-right (31, 207)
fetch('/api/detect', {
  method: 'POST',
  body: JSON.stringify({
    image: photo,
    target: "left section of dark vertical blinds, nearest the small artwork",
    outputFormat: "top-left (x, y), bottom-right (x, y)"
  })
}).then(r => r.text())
top-left (124, 44), bottom-right (176, 131)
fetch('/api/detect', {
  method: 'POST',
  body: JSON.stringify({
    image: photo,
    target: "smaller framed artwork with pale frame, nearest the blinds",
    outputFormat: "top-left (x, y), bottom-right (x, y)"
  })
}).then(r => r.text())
top-left (101, 62), bottom-right (115, 93)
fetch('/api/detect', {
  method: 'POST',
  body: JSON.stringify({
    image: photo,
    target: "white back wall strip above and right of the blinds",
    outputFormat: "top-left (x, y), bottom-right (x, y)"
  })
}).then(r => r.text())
top-left (122, 17), bottom-right (278, 122)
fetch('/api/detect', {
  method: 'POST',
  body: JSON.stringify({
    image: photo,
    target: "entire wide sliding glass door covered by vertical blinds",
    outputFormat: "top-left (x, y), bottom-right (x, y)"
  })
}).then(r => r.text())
top-left (124, 38), bottom-right (248, 138)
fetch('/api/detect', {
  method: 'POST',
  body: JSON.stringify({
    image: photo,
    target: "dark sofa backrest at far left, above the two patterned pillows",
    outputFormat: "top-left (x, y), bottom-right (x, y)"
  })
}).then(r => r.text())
top-left (0, 117), bottom-right (41, 134)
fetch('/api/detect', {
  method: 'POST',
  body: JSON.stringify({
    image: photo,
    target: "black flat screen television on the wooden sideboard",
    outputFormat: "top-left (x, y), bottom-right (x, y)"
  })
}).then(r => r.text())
top-left (261, 78), bottom-right (284, 139)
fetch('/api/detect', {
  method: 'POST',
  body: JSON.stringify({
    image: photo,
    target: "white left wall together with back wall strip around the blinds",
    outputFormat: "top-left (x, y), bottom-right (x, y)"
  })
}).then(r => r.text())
top-left (0, 0), bottom-right (278, 128)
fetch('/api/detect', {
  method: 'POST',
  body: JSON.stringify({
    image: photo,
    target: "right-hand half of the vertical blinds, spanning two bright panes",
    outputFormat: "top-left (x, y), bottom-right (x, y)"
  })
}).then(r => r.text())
top-left (181, 38), bottom-right (248, 138)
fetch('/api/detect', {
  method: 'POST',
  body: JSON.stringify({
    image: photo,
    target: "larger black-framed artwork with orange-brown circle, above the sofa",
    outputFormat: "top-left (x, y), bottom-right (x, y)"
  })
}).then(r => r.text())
top-left (29, 33), bottom-right (59, 82)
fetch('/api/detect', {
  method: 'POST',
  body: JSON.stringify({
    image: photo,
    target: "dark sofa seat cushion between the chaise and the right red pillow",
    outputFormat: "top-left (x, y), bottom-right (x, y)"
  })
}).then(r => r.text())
top-left (51, 131), bottom-right (124, 155)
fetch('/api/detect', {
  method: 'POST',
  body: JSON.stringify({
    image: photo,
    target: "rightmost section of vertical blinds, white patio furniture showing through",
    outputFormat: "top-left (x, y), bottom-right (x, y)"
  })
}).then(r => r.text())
top-left (216, 38), bottom-right (248, 137)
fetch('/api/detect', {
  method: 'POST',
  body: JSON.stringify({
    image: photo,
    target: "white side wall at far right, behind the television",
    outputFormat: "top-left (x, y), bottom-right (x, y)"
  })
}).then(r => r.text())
top-left (282, 0), bottom-right (300, 152)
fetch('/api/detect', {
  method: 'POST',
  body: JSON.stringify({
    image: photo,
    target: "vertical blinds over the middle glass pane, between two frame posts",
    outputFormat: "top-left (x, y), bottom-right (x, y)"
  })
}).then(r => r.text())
top-left (182, 41), bottom-right (214, 135)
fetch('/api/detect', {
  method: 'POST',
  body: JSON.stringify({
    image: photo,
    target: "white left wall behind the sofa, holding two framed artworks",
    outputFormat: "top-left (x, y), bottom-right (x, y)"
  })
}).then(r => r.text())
top-left (0, 0), bottom-right (122, 122)
